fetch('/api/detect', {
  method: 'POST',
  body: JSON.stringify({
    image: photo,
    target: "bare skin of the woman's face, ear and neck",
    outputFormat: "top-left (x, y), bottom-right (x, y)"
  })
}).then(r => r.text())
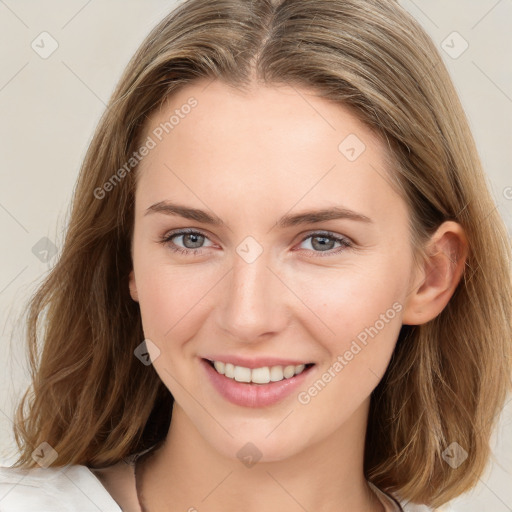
top-left (125, 81), bottom-right (467, 512)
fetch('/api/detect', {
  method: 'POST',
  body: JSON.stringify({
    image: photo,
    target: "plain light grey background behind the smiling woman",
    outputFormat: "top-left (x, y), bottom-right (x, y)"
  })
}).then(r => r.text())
top-left (0, 0), bottom-right (512, 512)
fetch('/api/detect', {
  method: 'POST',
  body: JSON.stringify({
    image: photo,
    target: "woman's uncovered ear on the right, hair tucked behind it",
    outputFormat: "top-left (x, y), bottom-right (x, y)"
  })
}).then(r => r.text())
top-left (402, 221), bottom-right (468, 325)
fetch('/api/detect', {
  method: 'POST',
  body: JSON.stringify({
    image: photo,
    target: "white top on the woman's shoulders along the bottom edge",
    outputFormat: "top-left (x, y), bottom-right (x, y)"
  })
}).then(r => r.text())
top-left (0, 465), bottom-right (432, 512)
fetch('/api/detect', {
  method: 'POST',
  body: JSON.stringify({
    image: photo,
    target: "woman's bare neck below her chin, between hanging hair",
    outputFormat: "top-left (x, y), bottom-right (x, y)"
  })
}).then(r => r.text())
top-left (138, 403), bottom-right (384, 512)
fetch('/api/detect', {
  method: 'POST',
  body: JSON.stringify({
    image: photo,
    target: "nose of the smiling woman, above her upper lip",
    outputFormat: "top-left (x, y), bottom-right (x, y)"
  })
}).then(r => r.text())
top-left (217, 252), bottom-right (293, 343)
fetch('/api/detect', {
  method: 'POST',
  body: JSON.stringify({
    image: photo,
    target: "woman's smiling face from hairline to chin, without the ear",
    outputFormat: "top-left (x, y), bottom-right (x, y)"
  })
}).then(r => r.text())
top-left (130, 82), bottom-right (420, 461)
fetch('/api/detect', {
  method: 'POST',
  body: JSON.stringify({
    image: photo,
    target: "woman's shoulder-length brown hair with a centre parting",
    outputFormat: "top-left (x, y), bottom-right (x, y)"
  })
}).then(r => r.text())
top-left (11, 0), bottom-right (512, 506)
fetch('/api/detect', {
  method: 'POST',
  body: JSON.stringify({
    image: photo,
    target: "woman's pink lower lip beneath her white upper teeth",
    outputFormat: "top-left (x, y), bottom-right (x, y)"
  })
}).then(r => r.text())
top-left (201, 359), bottom-right (313, 407)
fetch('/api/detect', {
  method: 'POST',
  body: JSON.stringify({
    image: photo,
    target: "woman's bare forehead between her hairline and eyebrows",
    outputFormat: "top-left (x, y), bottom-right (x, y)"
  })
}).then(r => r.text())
top-left (137, 81), bottom-right (404, 224)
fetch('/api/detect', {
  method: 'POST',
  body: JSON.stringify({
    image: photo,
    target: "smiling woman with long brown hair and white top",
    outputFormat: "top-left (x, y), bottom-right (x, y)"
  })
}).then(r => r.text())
top-left (0, 0), bottom-right (512, 512)
